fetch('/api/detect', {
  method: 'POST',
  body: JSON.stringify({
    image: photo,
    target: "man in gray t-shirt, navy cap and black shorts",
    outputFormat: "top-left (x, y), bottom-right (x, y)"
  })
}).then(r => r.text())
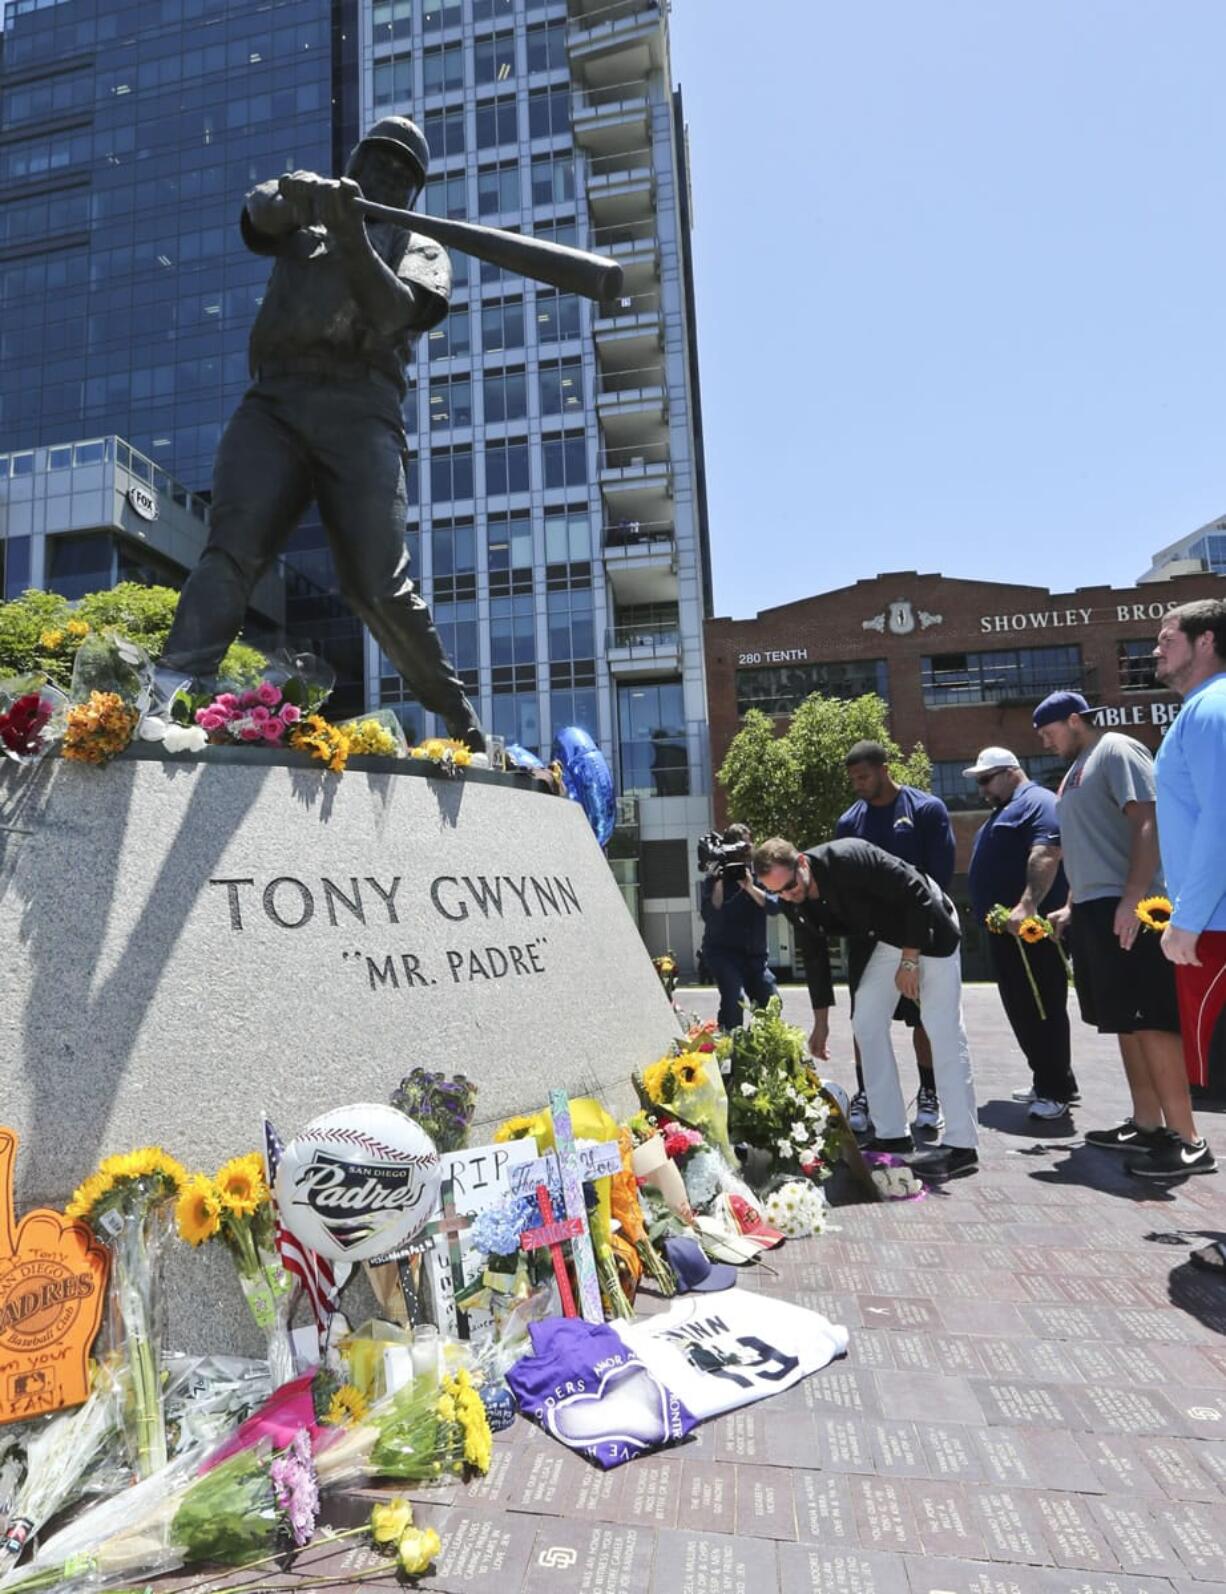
top-left (1035, 692), bottom-right (1213, 1178)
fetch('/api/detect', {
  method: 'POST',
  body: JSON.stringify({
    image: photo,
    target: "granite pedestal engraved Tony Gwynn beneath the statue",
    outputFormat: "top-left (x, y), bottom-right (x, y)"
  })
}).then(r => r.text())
top-left (0, 748), bottom-right (678, 1349)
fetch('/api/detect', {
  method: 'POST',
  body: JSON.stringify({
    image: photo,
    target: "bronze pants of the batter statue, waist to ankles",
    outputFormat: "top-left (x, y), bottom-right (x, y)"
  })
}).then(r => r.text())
top-left (161, 375), bottom-right (485, 751)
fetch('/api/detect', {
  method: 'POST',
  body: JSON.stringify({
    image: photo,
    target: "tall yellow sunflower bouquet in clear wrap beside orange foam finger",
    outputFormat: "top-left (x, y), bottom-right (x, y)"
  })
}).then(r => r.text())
top-left (65, 1146), bottom-right (187, 1479)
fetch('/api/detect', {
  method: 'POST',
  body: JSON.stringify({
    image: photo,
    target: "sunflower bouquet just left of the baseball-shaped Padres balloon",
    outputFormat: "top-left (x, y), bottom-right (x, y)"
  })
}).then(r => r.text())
top-left (175, 1151), bottom-right (293, 1388)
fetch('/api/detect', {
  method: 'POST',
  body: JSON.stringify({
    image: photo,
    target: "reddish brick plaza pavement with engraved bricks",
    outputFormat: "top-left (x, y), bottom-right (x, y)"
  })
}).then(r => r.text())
top-left (167, 987), bottom-right (1226, 1594)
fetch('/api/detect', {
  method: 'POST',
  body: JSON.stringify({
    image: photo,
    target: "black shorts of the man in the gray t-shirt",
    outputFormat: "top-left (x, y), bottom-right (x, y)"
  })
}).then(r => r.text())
top-left (1068, 897), bottom-right (1180, 1035)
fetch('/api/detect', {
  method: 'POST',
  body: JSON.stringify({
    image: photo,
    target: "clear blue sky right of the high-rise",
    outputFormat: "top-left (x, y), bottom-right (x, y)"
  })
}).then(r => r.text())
top-left (673, 0), bottom-right (1226, 615)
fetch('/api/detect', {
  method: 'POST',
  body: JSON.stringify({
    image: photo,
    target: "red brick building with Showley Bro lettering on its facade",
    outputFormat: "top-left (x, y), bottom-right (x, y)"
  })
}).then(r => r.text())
top-left (706, 571), bottom-right (1226, 968)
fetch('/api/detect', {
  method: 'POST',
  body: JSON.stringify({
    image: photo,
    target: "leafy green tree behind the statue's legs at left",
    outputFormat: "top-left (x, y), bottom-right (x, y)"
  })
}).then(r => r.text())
top-left (0, 582), bottom-right (268, 690)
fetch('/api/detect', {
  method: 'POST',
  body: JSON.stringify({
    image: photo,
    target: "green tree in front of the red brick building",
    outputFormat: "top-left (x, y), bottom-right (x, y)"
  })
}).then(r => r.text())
top-left (716, 692), bottom-right (933, 848)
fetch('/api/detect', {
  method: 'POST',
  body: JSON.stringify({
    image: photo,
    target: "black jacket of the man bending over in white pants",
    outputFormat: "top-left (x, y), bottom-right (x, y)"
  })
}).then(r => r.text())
top-left (780, 837), bottom-right (961, 1009)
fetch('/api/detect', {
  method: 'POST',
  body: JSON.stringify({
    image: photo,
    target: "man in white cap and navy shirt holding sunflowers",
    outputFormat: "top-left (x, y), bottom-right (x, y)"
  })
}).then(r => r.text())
top-left (963, 748), bottom-right (1078, 1119)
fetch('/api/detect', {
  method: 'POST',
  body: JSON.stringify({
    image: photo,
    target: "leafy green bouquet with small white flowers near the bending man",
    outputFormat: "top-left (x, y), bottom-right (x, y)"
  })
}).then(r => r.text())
top-left (729, 996), bottom-right (842, 1180)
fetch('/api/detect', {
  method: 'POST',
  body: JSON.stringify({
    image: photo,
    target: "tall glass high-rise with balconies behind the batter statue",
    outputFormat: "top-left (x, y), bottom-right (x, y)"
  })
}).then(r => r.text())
top-left (0, 0), bottom-right (711, 963)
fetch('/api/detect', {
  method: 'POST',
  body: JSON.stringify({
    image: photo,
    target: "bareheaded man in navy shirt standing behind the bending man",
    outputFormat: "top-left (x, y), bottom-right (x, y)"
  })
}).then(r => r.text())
top-left (834, 741), bottom-right (955, 1151)
